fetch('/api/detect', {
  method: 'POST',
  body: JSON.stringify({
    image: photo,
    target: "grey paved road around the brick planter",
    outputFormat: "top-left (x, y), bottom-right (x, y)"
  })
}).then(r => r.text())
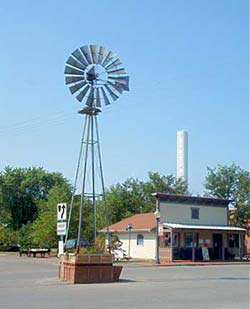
top-left (0, 256), bottom-right (249, 309)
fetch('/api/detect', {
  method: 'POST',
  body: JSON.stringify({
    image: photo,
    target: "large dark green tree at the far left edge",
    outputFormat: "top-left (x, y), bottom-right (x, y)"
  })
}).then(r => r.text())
top-left (0, 167), bottom-right (68, 230)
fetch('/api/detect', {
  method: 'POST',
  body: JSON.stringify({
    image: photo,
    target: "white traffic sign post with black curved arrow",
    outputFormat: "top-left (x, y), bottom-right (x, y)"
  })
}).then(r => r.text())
top-left (57, 203), bottom-right (67, 256)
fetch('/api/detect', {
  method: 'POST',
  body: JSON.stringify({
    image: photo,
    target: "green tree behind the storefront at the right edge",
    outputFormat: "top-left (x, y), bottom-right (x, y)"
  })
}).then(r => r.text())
top-left (205, 164), bottom-right (250, 225)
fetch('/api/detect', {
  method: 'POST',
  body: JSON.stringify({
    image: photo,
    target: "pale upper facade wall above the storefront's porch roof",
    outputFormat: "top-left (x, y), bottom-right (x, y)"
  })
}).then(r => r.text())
top-left (160, 202), bottom-right (227, 225)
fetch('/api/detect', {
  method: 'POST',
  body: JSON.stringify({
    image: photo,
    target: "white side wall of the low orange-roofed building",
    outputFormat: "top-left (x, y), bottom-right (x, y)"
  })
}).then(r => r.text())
top-left (117, 232), bottom-right (156, 259)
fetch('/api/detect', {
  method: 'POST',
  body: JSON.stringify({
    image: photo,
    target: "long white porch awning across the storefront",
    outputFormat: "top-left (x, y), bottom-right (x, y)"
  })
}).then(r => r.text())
top-left (163, 222), bottom-right (246, 232)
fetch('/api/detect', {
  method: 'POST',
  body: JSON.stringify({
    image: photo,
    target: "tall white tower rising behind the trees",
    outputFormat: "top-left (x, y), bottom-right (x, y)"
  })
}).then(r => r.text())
top-left (176, 130), bottom-right (188, 182)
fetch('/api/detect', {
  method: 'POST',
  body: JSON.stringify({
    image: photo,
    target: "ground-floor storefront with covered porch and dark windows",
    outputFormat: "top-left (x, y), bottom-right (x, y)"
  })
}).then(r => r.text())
top-left (160, 223), bottom-right (245, 261)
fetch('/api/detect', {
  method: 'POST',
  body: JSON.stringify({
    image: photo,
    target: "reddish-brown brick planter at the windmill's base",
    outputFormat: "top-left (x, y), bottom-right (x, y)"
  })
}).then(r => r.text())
top-left (59, 254), bottom-right (122, 284)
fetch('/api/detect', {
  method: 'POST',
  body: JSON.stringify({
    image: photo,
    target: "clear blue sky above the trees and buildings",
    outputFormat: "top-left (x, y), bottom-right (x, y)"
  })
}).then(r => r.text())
top-left (0, 0), bottom-right (249, 193)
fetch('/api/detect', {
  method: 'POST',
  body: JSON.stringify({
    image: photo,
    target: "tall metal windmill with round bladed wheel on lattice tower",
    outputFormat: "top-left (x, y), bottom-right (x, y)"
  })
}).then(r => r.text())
top-left (64, 45), bottom-right (129, 252)
